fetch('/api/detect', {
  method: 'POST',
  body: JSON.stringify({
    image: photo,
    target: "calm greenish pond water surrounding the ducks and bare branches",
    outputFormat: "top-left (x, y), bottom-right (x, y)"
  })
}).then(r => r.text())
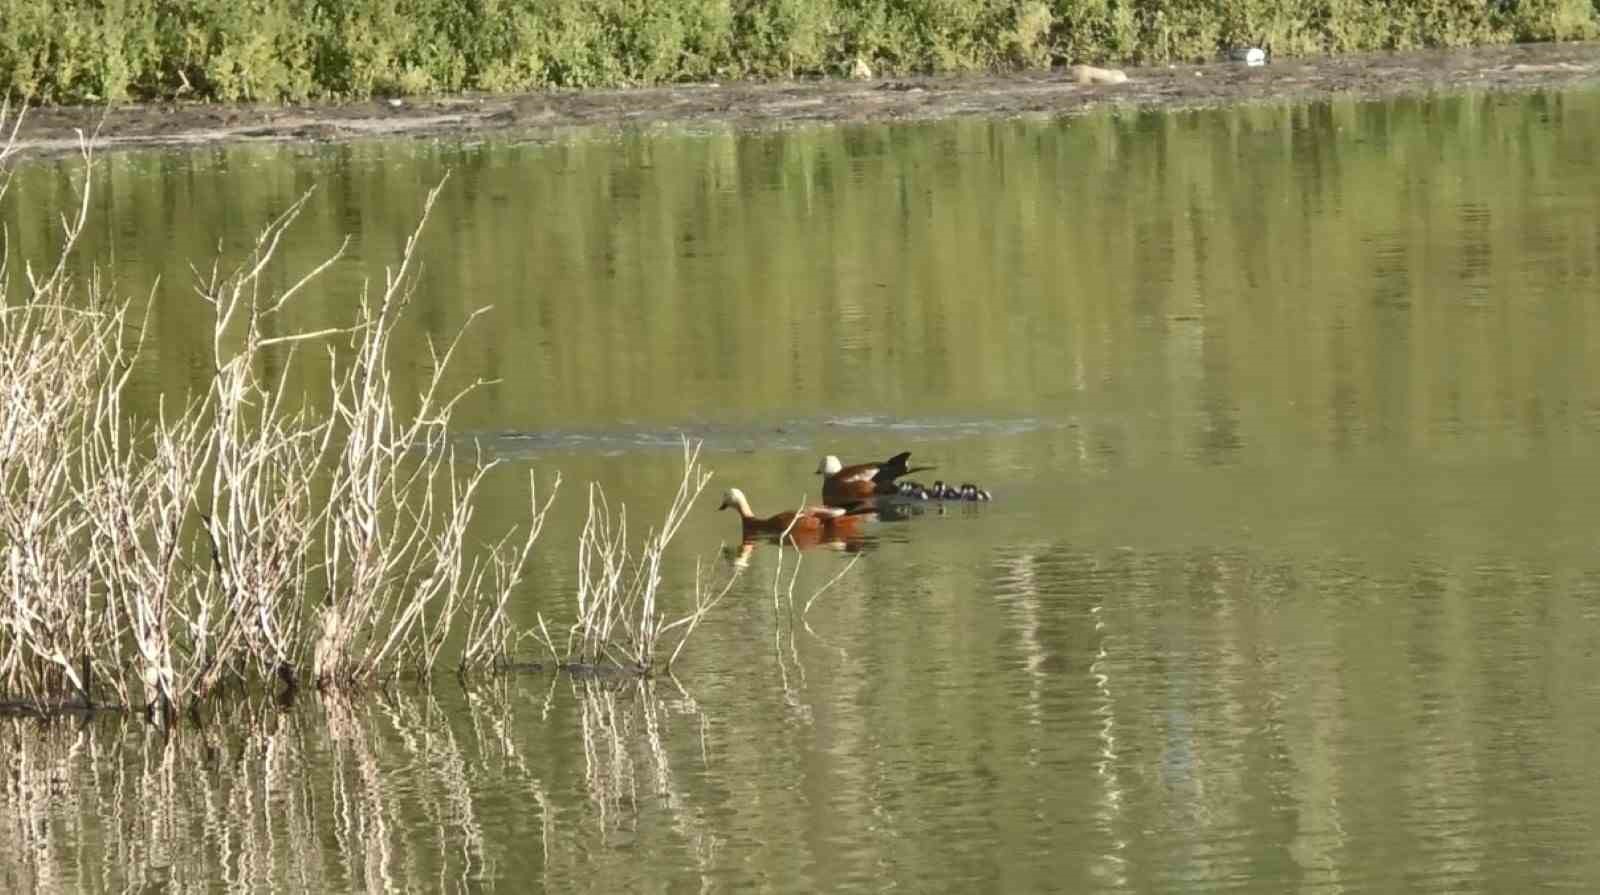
top-left (0, 91), bottom-right (1600, 892)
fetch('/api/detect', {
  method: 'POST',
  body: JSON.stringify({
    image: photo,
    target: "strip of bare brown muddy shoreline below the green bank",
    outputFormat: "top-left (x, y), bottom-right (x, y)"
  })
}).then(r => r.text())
top-left (16, 43), bottom-right (1600, 157)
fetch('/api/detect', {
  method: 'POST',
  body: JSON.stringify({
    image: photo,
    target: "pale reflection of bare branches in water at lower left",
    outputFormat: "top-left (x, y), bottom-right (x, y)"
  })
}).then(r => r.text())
top-left (0, 674), bottom-right (723, 892)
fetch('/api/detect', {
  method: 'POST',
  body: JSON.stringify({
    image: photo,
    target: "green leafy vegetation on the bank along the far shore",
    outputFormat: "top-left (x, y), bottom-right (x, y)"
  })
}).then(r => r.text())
top-left (0, 0), bottom-right (1600, 102)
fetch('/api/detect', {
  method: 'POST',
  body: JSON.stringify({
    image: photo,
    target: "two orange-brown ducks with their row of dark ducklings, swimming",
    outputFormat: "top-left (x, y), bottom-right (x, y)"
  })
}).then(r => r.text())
top-left (717, 452), bottom-right (994, 540)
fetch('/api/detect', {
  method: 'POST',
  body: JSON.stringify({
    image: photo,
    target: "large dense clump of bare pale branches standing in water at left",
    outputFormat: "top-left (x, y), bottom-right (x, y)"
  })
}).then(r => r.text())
top-left (0, 104), bottom-right (558, 716)
